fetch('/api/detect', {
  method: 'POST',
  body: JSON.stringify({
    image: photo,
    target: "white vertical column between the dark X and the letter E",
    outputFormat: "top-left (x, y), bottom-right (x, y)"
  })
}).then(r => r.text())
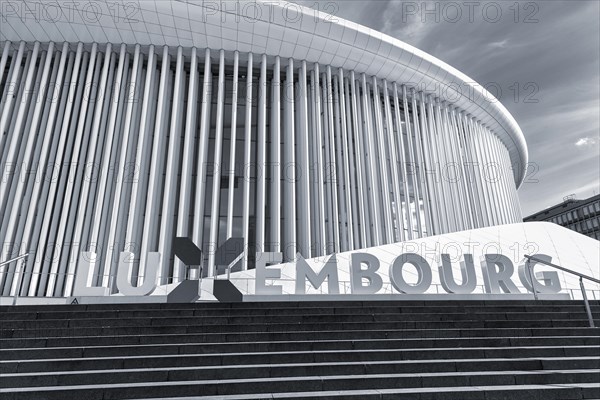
top-left (242, 53), bottom-right (252, 269)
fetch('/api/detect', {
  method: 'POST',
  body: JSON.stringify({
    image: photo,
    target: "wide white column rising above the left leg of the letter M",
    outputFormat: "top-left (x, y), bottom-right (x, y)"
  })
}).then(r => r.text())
top-left (296, 61), bottom-right (312, 258)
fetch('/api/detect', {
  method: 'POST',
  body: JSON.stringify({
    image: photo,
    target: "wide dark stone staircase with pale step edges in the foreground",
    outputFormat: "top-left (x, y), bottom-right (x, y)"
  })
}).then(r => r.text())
top-left (0, 301), bottom-right (600, 400)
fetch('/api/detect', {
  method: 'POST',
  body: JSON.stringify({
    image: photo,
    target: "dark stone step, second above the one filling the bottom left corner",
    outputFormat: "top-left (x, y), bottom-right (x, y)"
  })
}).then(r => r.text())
top-left (0, 346), bottom-right (600, 373)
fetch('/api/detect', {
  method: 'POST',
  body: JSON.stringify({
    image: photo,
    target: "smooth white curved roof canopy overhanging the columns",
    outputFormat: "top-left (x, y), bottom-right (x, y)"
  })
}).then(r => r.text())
top-left (0, 0), bottom-right (528, 185)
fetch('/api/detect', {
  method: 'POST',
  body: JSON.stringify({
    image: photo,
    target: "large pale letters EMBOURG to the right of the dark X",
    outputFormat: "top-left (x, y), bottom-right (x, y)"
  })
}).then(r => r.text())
top-left (255, 252), bottom-right (561, 295)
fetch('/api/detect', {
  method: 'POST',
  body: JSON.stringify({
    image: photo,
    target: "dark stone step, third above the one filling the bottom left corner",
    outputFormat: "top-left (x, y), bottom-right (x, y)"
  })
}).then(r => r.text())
top-left (0, 336), bottom-right (600, 361)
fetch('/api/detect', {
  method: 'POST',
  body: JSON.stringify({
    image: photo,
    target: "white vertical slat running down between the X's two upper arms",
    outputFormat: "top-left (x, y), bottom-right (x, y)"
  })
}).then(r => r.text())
top-left (208, 50), bottom-right (225, 276)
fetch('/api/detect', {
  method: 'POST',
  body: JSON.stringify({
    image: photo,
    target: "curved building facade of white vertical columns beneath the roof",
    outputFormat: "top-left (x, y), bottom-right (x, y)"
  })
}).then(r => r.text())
top-left (0, 2), bottom-right (526, 296)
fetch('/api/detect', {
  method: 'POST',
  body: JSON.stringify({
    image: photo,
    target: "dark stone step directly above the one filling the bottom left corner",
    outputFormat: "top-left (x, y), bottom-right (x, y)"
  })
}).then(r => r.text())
top-left (0, 357), bottom-right (600, 388)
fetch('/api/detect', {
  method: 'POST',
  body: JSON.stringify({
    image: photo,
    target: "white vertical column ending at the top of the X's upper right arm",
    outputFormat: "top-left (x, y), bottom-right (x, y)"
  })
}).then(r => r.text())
top-left (227, 51), bottom-right (240, 239)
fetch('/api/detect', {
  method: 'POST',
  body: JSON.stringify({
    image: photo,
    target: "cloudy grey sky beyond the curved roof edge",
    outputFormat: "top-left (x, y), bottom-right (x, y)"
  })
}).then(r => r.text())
top-left (297, 0), bottom-right (600, 216)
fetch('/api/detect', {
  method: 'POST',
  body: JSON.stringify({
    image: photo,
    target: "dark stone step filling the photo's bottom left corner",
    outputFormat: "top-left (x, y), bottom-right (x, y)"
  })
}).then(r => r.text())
top-left (2, 369), bottom-right (600, 400)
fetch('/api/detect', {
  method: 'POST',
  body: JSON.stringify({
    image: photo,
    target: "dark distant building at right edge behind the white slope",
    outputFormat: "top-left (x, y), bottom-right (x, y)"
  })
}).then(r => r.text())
top-left (524, 195), bottom-right (600, 240)
